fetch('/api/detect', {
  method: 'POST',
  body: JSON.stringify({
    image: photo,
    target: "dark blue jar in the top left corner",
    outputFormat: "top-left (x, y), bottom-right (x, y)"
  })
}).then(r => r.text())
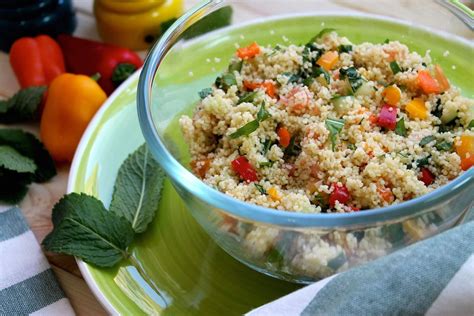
top-left (0, 0), bottom-right (77, 52)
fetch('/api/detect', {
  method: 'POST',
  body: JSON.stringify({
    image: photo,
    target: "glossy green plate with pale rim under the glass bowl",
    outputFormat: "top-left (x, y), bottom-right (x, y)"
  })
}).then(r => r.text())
top-left (68, 12), bottom-right (474, 315)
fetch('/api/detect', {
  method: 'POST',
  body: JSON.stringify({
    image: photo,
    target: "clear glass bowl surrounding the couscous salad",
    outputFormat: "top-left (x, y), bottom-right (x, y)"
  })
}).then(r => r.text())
top-left (138, 1), bottom-right (474, 283)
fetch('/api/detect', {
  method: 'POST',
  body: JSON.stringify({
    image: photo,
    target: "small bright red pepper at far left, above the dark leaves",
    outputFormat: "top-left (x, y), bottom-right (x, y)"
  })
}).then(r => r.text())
top-left (10, 35), bottom-right (66, 88)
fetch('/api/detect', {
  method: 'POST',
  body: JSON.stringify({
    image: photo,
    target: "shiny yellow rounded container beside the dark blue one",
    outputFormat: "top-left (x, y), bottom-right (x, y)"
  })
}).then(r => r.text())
top-left (94, 0), bottom-right (183, 50)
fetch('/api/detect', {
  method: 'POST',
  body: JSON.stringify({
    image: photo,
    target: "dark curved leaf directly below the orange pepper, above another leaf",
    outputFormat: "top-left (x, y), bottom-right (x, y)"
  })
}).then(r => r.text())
top-left (0, 129), bottom-right (56, 182)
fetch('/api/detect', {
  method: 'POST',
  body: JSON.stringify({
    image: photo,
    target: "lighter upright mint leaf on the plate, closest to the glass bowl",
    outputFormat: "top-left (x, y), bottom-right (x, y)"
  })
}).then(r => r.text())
top-left (110, 145), bottom-right (165, 233)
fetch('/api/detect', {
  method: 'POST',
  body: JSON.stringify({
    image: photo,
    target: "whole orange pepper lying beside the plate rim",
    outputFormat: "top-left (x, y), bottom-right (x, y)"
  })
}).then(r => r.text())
top-left (40, 73), bottom-right (107, 162)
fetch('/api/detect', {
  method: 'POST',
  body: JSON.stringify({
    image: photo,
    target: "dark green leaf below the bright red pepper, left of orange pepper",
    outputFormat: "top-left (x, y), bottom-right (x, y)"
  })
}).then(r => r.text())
top-left (0, 87), bottom-right (46, 124)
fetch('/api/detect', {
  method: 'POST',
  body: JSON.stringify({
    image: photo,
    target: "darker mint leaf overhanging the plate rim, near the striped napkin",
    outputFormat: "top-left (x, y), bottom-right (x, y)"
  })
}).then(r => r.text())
top-left (43, 193), bottom-right (134, 267)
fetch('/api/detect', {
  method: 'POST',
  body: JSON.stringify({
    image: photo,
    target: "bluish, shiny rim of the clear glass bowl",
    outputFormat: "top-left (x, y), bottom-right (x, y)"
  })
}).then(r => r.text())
top-left (137, 0), bottom-right (474, 229)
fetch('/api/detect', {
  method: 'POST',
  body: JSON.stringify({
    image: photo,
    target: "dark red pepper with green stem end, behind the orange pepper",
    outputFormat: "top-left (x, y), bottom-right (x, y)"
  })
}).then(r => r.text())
top-left (58, 35), bottom-right (143, 95)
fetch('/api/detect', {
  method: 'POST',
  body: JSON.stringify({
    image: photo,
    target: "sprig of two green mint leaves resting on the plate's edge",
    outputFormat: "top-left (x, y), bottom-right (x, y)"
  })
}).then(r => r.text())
top-left (43, 145), bottom-right (165, 266)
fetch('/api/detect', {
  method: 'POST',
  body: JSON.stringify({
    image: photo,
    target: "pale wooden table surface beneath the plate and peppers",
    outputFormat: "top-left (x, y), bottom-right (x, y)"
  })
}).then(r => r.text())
top-left (0, 0), bottom-right (473, 315)
